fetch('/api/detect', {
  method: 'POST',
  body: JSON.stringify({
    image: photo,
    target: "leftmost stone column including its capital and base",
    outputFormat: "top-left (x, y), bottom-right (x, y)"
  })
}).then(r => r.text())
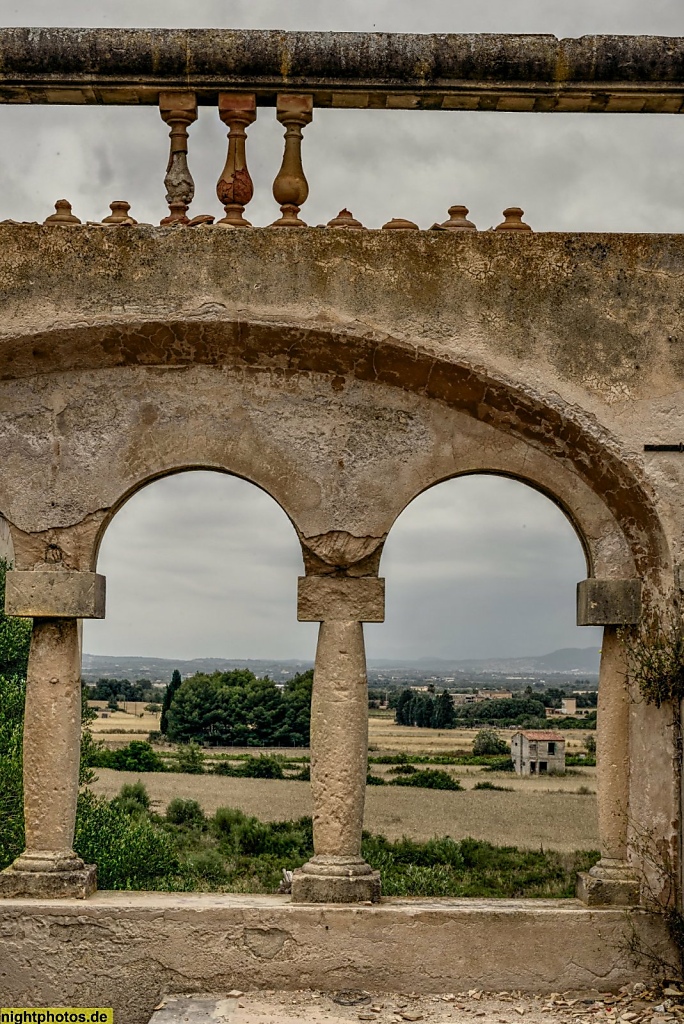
top-left (0, 571), bottom-right (104, 899)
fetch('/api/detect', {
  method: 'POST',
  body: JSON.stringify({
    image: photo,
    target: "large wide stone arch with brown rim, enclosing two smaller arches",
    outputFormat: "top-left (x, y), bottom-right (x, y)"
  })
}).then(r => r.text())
top-left (0, 310), bottom-right (670, 582)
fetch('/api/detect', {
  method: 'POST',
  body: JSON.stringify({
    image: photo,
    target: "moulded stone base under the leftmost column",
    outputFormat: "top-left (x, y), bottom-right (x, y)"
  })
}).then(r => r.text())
top-left (0, 851), bottom-right (97, 899)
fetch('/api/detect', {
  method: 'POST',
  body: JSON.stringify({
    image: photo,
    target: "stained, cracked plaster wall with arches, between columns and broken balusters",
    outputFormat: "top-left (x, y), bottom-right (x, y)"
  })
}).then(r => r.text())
top-left (0, 223), bottom-right (684, 897)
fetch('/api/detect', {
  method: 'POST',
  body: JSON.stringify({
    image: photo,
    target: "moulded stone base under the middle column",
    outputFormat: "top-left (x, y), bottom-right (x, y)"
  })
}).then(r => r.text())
top-left (292, 855), bottom-right (380, 903)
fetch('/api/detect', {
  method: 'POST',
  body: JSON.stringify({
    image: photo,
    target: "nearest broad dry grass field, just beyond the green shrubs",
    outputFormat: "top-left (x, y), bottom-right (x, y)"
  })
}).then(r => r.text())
top-left (92, 768), bottom-right (598, 851)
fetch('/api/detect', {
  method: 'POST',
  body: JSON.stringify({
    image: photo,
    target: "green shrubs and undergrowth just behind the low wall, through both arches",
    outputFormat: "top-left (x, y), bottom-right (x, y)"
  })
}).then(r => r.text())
top-left (62, 784), bottom-right (598, 898)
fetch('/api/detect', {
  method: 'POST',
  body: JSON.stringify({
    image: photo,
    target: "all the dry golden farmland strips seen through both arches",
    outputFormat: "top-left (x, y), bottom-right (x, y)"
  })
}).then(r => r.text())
top-left (92, 705), bottom-right (598, 852)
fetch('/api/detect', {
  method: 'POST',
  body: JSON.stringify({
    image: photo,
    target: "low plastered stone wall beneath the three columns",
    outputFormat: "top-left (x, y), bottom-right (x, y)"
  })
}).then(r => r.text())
top-left (0, 892), bottom-right (666, 1024)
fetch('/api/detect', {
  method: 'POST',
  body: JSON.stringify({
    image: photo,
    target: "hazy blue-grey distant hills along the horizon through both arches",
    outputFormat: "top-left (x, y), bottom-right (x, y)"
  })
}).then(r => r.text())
top-left (83, 647), bottom-right (599, 683)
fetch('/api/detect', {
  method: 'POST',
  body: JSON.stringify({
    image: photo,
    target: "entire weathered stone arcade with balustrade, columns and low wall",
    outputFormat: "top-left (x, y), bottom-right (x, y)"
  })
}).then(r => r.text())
top-left (0, 22), bottom-right (684, 1024)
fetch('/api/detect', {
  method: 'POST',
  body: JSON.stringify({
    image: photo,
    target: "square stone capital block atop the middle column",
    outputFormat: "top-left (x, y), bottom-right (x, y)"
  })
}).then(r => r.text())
top-left (297, 577), bottom-right (385, 623)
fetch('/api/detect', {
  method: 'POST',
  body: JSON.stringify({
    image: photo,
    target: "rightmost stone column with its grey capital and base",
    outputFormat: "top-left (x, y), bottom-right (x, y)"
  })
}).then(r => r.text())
top-left (578, 580), bottom-right (641, 906)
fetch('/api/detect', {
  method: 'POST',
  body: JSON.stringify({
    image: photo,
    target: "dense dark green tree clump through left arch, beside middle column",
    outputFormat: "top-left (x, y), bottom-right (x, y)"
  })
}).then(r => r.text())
top-left (167, 669), bottom-right (313, 746)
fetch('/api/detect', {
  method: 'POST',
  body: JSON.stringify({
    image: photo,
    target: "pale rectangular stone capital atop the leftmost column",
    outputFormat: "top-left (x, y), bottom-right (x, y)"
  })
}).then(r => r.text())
top-left (5, 569), bottom-right (105, 618)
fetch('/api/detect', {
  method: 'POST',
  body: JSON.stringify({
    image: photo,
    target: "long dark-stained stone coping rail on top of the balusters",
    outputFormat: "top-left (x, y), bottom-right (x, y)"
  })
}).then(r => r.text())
top-left (0, 28), bottom-right (684, 113)
